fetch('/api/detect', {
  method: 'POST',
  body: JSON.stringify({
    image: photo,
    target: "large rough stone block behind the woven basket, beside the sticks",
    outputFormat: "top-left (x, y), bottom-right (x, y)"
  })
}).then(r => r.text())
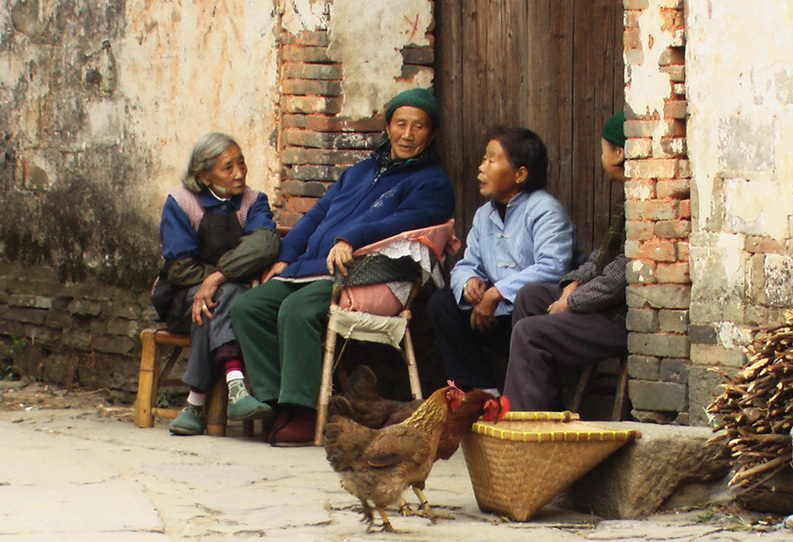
top-left (560, 422), bottom-right (730, 520)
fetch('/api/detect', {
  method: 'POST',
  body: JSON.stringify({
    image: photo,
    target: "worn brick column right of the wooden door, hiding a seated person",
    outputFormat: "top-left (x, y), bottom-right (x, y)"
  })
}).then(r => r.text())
top-left (624, 0), bottom-right (691, 423)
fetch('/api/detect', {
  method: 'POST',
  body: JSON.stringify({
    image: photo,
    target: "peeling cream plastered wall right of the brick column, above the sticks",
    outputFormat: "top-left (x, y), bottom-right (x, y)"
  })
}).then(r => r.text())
top-left (686, 0), bottom-right (793, 422)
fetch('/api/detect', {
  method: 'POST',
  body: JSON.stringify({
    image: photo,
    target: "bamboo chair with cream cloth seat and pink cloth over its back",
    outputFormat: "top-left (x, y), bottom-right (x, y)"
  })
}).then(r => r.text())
top-left (314, 219), bottom-right (460, 446)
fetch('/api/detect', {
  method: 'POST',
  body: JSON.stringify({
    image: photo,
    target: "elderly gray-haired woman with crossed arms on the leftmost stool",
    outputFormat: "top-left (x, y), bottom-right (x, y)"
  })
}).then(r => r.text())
top-left (152, 133), bottom-right (280, 435)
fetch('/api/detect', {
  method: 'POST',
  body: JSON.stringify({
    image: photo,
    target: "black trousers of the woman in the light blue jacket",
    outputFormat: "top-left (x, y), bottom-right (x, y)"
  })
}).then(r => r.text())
top-left (427, 288), bottom-right (512, 389)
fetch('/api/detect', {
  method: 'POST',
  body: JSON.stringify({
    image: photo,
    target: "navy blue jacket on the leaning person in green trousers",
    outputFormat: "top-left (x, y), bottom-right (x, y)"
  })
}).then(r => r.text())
top-left (278, 155), bottom-right (454, 278)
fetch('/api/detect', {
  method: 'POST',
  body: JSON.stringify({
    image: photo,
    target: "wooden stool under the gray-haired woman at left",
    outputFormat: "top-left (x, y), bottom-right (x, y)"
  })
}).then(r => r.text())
top-left (135, 328), bottom-right (238, 437)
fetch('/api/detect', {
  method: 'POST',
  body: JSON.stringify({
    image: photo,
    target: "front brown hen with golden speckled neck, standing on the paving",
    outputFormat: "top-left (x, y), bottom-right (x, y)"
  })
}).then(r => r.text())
top-left (324, 383), bottom-right (463, 532)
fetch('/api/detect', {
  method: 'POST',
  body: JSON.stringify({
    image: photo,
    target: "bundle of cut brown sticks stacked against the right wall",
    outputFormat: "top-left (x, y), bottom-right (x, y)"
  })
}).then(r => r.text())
top-left (707, 310), bottom-right (793, 491)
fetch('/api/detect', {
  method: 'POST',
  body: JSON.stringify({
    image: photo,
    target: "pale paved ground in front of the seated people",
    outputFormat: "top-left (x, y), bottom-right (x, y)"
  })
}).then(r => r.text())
top-left (0, 386), bottom-right (793, 542)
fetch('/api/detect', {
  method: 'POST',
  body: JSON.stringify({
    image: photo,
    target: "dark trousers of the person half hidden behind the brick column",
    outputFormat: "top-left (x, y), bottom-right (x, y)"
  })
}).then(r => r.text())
top-left (504, 284), bottom-right (628, 411)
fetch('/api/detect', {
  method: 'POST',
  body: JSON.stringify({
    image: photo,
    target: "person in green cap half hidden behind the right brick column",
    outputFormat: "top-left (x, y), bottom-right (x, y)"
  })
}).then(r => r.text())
top-left (504, 112), bottom-right (628, 411)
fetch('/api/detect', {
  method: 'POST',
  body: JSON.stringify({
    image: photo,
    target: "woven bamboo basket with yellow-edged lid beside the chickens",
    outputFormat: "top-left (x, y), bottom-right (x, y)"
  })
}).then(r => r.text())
top-left (462, 412), bottom-right (641, 521)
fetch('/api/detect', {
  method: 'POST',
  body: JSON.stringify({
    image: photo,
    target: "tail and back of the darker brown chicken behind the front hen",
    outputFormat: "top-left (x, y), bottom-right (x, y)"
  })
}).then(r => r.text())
top-left (343, 365), bottom-right (422, 429)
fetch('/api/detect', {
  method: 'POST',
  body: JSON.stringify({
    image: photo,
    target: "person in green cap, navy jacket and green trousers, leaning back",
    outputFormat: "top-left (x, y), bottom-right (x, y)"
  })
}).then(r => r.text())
top-left (231, 88), bottom-right (454, 446)
